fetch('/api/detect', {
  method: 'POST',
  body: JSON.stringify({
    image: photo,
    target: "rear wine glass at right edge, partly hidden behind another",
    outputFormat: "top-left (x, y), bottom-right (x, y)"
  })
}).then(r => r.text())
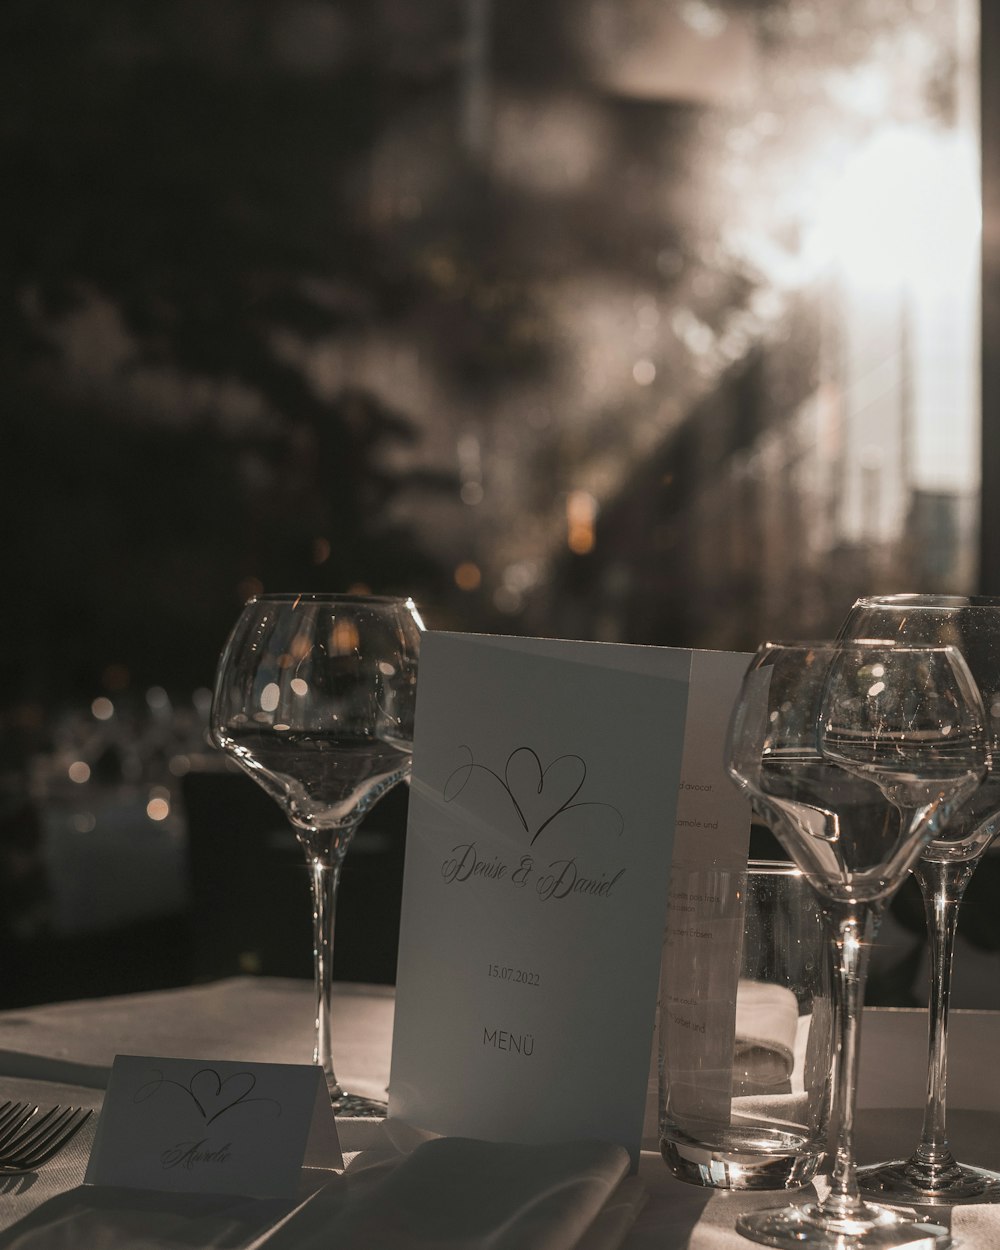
top-left (840, 595), bottom-right (1000, 1205)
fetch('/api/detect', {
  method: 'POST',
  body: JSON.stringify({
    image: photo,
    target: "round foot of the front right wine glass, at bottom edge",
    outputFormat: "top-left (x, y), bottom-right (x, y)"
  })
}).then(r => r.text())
top-left (736, 1203), bottom-right (951, 1250)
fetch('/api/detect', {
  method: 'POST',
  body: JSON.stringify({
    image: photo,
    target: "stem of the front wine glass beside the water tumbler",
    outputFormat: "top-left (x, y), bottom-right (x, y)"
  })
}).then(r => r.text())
top-left (821, 903), bottom-right (881, 1219)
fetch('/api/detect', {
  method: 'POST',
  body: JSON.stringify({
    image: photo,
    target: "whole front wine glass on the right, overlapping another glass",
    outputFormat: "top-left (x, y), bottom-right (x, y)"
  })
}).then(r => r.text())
top-left (728, 640), bottom-right (986, 1250)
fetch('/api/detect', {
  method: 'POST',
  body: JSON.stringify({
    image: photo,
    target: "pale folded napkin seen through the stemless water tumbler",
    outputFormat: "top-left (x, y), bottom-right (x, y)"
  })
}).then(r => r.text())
top-left (733, 980), bottom-right (799, 1094)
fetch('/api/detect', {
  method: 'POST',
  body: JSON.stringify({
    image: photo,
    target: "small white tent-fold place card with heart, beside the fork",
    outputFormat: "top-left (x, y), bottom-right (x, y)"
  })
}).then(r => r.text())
top-left (84, 1055), bottom-right (344, 1198)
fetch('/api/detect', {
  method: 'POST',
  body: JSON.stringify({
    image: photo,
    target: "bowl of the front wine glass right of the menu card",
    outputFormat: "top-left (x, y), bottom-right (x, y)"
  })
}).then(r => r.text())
top-left (728, 640), bottom-right (986, 901)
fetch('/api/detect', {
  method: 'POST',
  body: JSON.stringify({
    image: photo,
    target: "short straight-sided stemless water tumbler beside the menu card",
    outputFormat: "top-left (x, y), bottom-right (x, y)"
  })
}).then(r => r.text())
top-left (658, 860), bottom-right (833, 1189)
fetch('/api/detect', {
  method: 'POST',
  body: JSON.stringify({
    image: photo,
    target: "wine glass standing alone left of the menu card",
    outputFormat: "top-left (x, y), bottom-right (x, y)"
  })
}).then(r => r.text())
top-left (211, 594), bottom-right (423, 1115)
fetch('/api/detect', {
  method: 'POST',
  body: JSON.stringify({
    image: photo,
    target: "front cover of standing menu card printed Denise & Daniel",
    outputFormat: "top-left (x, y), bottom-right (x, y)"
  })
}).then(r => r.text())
top-left (389, 633), bottom-right (749, 1159)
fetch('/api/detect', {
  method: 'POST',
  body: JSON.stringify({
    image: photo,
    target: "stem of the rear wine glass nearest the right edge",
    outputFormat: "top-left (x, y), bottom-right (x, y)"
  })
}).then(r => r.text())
top-left (911, 859), bottom-right (976, 1168)
